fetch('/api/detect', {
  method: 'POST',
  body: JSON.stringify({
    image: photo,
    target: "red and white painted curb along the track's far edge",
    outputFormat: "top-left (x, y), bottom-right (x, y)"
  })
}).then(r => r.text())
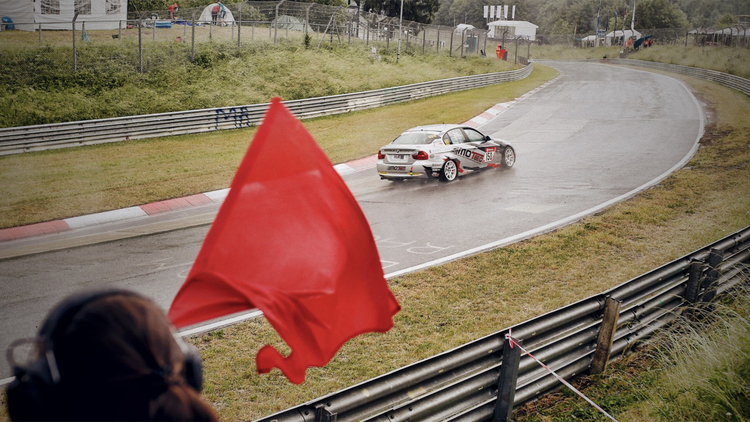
top-left (0, 76), bottom-right (560, 243)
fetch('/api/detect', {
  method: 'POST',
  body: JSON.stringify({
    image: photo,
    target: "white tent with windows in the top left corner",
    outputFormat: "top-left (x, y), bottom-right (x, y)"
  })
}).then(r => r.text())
top-left (0, 0), bottom-right (128, 31)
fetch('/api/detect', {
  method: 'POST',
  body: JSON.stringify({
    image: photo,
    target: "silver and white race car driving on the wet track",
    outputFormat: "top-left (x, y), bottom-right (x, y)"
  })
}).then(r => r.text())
top-left (377, 124), bottom-right (516, 182)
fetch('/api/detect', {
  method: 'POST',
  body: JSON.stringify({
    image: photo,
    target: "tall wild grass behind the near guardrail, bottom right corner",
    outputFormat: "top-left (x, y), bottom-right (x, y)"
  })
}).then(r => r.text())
top-left (634, 269), bottom-right (750, 421)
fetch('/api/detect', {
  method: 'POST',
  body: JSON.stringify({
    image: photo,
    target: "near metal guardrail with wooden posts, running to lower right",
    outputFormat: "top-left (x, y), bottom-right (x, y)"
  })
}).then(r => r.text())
top-left (258, 227), bottom-right (750, 422)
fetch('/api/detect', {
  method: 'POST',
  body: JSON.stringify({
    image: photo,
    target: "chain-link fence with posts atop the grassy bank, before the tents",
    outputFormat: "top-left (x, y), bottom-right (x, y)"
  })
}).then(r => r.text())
top-left (2, 0), bottom-right (528, 72)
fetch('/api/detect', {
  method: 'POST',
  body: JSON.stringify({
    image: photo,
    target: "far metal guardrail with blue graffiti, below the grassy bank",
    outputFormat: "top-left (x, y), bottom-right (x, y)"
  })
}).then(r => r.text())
top-left (0, 64), bottom-right (534, 155)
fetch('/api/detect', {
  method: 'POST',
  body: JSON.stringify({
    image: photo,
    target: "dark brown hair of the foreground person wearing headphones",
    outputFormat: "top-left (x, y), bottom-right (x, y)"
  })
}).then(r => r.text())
top-left (8, 293), bottom-right (218, 421)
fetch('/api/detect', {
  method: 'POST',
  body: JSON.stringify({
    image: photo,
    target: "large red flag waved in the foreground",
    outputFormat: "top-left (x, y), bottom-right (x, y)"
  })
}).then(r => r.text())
top-left (168, 98), bottom-right (400, 384)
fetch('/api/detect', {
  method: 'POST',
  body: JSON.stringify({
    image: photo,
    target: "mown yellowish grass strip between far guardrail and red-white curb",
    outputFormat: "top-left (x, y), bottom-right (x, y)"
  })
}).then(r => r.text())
top-left (0, 66), bottom-right (557, 228)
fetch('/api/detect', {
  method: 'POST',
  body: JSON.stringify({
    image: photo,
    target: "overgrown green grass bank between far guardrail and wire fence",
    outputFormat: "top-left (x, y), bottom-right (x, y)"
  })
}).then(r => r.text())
top-left (0, 32), bottom-right (513, 127)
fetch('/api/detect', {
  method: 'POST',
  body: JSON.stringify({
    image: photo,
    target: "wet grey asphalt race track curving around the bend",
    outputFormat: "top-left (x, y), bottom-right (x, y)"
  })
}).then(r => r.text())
top-left (0, 62), bottom-right (703, 379)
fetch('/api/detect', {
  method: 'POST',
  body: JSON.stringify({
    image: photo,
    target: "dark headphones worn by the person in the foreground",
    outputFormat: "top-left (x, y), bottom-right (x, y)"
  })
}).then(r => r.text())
top-left (7, 289), bottom-right (203, 420)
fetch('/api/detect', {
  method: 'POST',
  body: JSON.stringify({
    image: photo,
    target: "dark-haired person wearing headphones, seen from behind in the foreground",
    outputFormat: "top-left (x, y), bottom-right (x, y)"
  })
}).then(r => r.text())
top-left (7, 290), bottom-right (217, 421)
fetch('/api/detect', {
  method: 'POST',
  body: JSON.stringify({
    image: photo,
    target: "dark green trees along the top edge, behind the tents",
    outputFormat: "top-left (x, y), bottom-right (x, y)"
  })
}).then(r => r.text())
top-left (128, 0), bottom-right (750, 34)
